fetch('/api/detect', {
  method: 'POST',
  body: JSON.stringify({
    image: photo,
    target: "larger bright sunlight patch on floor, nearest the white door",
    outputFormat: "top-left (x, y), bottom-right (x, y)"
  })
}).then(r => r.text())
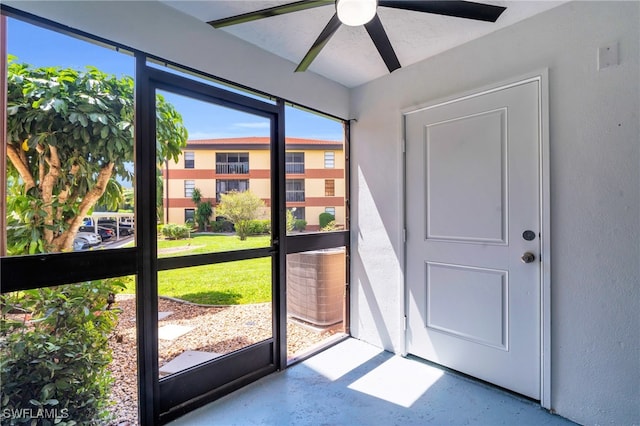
top-left (348, 356), bottom-right (444, 408)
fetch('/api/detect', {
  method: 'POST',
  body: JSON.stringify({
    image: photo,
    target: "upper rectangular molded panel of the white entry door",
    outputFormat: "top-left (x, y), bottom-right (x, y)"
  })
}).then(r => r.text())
top-left (423, 108), bottom-right (509, 245)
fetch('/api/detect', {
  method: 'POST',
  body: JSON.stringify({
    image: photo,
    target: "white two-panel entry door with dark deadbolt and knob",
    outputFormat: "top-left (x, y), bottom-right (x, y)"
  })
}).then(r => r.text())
top-left (405, 81), bottom-right (541, 399)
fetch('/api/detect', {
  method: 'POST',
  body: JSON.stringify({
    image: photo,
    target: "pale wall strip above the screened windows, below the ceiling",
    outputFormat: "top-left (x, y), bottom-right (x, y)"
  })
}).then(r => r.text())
top-left (3, 0), bottom-right (349, 118)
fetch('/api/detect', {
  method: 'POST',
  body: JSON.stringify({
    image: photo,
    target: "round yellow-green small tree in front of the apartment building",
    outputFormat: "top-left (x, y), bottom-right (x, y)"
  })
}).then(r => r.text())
top-left (216, 191), bottom-right (264, 240)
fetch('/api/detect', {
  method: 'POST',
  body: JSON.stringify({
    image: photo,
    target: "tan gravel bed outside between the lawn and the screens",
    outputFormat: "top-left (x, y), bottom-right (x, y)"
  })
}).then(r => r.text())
top-left (110, 294), bottom-right (341, 426)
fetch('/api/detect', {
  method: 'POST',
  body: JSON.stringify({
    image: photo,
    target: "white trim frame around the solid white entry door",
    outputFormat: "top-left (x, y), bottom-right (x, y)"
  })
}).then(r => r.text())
top-left (400, 68), bottom-right (551, 409)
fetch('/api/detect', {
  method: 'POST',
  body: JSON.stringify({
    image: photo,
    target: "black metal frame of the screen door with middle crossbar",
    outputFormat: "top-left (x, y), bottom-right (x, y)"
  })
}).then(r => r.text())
top-left (135, 54), bottom-right (286, 423)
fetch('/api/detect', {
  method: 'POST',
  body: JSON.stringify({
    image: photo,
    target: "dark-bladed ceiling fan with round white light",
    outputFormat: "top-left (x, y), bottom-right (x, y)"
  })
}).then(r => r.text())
top-left (208, 0), bottom-right (506, 72)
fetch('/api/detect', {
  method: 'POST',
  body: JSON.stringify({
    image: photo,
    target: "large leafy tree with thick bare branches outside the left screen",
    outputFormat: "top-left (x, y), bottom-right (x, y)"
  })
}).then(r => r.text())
top-left (7, 55), bottom-right (187, 254)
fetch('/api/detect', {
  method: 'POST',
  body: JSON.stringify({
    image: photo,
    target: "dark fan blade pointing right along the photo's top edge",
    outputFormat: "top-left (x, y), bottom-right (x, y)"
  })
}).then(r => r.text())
top-left (378, 0), bottom-right (506, 22)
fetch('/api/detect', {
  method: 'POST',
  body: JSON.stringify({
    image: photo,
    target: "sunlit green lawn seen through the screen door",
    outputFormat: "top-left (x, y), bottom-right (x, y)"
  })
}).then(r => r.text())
top-left (122, 235), bottom-right (271, 305)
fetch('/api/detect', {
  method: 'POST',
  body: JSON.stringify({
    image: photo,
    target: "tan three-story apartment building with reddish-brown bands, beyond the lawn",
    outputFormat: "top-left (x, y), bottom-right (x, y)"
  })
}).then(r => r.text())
top-left (163, 137), bottom-right (345, 231)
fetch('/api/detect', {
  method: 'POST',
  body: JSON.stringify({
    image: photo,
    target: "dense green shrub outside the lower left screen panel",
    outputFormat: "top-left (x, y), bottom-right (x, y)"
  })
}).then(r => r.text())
top-left (0, 279), bottom-right (124, 425)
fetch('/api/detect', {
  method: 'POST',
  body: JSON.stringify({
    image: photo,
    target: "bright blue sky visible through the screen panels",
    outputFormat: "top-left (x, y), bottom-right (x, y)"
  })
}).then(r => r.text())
top-left (7, 19), bottom-right (343, 140)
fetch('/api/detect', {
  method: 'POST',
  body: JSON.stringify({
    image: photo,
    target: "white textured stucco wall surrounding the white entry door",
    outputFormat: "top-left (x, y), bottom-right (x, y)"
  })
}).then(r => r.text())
top-left (351, 2), bottom-right (640, 424)
